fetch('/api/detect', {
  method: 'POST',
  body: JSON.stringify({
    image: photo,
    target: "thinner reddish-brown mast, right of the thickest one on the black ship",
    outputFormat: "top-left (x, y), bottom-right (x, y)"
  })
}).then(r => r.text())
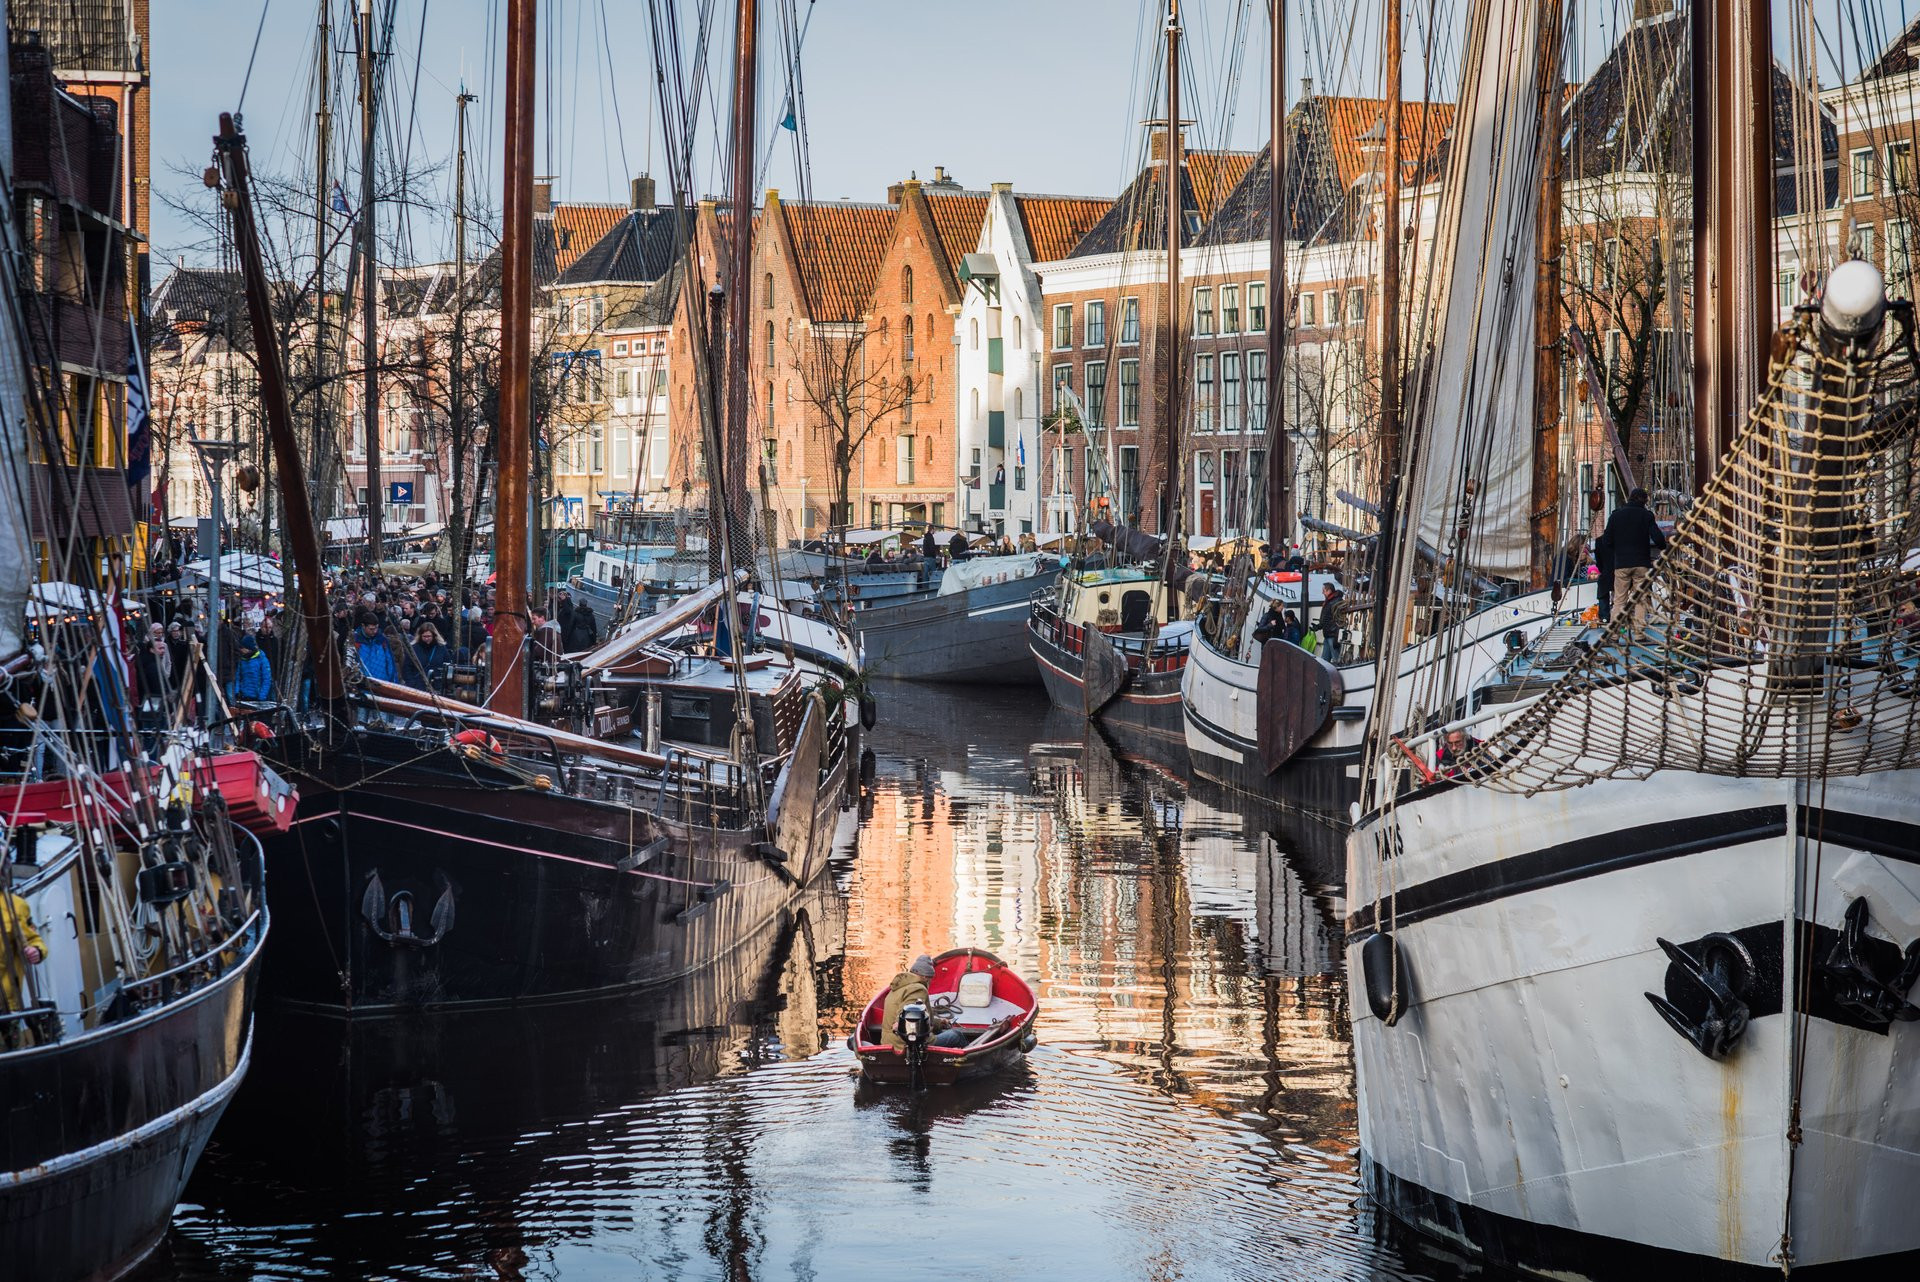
top-left (718, 0), bottom-right (760, 566)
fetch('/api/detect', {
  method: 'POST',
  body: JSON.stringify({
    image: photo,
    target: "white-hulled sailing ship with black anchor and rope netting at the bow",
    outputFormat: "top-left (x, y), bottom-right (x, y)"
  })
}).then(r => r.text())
top-left (1346, 2), bottom-right (1920, 1278)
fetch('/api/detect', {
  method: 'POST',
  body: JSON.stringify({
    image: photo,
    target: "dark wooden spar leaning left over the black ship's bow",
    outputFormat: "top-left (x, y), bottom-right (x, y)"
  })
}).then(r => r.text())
top-left (213, 111), bottom-right (342, 710)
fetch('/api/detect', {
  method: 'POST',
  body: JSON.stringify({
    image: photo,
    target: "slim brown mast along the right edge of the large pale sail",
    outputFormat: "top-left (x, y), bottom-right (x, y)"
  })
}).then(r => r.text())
top-left (1532, 0), bottom-right (1563, 587)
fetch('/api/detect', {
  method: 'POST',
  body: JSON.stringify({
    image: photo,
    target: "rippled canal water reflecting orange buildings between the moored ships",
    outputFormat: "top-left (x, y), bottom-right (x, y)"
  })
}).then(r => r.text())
top-left (154, 687), bottom-right (1453, 1282)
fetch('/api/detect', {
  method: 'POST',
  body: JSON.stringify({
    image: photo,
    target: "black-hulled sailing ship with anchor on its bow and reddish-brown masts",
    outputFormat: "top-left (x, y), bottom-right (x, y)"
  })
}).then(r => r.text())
top-left (204, 0), bottom-right (858, 1015)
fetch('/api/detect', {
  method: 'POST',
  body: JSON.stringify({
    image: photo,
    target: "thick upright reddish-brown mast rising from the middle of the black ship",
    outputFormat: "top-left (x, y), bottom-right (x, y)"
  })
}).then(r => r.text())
top-left (488, 0), bottom-right (536, 716)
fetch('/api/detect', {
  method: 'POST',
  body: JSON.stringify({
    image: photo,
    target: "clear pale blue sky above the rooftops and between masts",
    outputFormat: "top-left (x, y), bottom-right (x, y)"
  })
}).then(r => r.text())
top-left (150, 0), bottom-right (1910, 274)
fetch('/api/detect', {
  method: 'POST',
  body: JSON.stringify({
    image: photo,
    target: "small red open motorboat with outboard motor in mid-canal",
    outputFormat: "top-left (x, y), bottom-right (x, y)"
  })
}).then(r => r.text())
top-left (847, 948), bottom-right (1041, 1088)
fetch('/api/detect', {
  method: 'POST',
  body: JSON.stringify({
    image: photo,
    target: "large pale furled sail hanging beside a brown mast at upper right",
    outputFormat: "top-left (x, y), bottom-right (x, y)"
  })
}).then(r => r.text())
top-left (1402, 0), bottom-right (1549, 578)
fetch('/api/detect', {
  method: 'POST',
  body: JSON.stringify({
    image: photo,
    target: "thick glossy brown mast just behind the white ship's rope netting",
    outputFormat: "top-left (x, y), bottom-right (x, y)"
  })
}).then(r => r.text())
top-left (1689, 0), bottom-right (1774, 493)
